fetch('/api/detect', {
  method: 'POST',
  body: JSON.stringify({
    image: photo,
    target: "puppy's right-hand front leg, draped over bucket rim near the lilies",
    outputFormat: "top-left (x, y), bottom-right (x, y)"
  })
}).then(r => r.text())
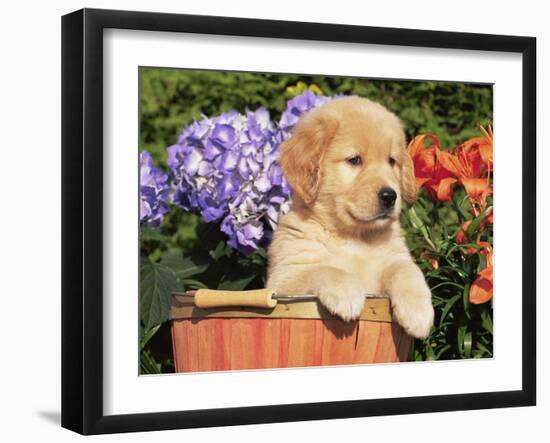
top-left (382, 259), bottom-right (434, 338)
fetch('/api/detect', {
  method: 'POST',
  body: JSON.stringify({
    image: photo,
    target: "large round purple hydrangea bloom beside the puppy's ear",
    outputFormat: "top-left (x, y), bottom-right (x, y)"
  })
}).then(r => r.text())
top-left (168, 108), bottom-right (290, 253)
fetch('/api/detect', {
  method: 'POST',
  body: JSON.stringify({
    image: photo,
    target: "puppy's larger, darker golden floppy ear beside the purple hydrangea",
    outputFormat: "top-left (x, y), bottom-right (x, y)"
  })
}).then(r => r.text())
top-left (279, 112), bottom-right (338, 205)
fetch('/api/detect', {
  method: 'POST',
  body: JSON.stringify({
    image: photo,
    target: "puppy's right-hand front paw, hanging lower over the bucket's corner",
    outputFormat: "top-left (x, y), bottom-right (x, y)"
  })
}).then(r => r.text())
top-left (392, 290), bottom-right (434, 338)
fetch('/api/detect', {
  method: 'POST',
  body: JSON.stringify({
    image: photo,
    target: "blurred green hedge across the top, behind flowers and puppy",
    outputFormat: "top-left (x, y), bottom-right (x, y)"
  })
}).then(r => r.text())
top-left (140, 68), bottom-right (493, 166)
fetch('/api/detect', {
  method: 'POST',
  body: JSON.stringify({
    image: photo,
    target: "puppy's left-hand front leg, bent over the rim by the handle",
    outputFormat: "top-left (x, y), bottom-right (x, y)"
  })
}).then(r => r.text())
top-left (268, 266), bottom-right (366, 321)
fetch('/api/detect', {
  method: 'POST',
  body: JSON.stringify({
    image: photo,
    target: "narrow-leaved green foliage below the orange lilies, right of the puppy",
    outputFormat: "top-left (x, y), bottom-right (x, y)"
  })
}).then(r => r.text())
top-left (401, 190), bottom-right (493, 361)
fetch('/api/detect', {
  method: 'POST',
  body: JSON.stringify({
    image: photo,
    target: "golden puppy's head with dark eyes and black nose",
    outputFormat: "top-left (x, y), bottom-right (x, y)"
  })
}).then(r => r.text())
top-left (280, 97), bottom-right (416, 236)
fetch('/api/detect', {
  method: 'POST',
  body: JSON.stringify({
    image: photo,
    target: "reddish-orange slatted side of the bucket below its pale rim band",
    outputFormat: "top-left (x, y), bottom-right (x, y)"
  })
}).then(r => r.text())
top-left (172, 318), bottom-right (412, 372)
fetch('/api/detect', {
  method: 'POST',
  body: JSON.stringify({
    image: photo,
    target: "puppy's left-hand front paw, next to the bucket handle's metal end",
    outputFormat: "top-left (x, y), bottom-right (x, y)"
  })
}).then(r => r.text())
top-left (319, 283), bottom-right (365, 322)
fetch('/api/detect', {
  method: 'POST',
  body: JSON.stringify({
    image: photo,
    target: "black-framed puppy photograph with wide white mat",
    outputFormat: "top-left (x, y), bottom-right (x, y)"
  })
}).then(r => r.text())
top-left (62, 9), bottom-right (536, 434)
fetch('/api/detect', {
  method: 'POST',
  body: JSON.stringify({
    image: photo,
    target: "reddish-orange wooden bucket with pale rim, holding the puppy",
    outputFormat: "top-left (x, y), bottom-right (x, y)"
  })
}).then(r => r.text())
top-left (171, 296), bottom-right (412, 372)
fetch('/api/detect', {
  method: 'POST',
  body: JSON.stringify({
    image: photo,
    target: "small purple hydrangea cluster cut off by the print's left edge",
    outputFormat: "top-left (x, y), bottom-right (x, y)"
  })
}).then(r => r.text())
top-left (139, 151), bottom-right (170, 226)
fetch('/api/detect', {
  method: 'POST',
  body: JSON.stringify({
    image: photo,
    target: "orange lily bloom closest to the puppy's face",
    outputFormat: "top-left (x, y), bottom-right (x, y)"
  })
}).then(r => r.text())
top-left (408, 134), bottom-right (457, 201)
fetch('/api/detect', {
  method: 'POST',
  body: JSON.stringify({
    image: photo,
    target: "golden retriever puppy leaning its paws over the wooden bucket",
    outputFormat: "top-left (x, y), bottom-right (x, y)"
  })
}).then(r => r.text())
top-left (267, 97), bottom-right (434, 338)
